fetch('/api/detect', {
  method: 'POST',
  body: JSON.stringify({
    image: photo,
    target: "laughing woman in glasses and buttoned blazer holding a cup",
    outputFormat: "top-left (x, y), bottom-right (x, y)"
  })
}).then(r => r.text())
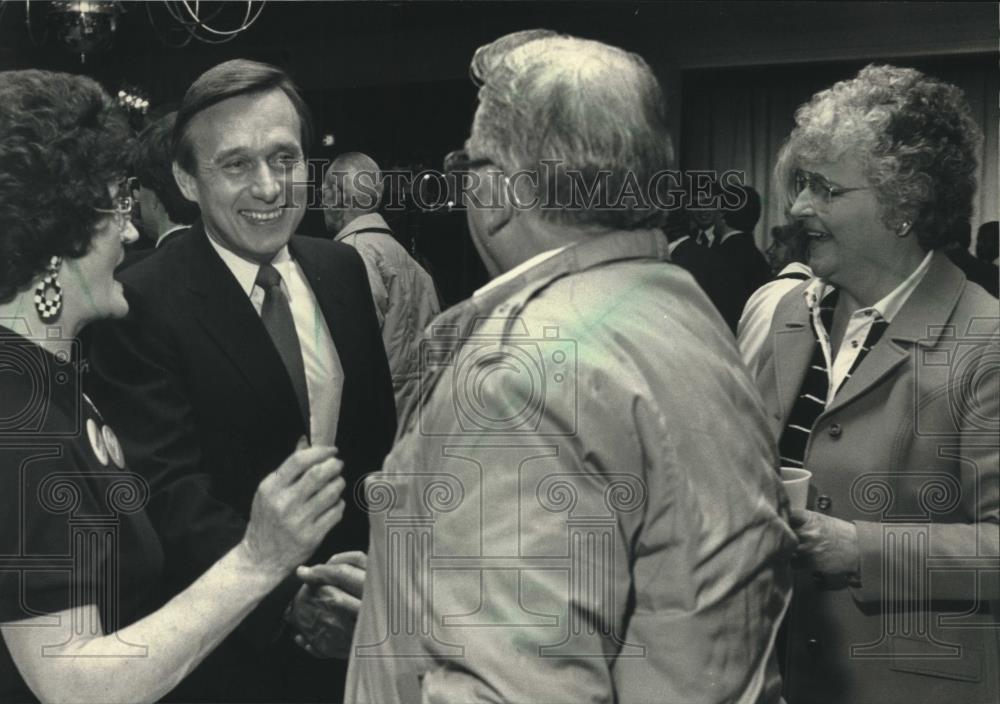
top-left (757, 66), bottom-right (1000, 704)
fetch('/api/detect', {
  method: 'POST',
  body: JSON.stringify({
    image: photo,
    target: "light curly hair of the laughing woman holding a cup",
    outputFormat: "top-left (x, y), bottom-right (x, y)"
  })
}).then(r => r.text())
top-left (775, 65), bottom-right (982, 250)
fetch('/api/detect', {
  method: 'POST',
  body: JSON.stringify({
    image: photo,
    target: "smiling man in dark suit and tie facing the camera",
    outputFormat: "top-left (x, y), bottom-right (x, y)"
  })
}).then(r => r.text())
top-left (89, 60), bottom-right (395, 701)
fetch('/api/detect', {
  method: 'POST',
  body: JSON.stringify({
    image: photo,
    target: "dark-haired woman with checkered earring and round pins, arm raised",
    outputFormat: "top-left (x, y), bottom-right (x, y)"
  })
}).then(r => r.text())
top-left (0, 71), bottom-right (344, 702)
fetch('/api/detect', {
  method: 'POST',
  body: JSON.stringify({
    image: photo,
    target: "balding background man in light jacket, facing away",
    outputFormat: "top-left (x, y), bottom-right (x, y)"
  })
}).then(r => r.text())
top-left (323, 152), bottom-right (441, 413)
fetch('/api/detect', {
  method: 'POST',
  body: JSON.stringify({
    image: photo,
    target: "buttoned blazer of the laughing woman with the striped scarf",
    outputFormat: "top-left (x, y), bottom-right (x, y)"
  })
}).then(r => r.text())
top-left (757, 253), bottom-right (1000, 704)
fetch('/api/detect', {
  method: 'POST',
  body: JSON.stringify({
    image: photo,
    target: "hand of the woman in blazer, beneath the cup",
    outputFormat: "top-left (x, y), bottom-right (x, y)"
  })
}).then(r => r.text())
top-left (790, 509), bottom-right (861, 577)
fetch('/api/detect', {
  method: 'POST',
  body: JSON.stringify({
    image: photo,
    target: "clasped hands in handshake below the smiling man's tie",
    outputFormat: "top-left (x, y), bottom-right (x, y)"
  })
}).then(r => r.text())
top-left (288, 551), bottom-right (368, 658)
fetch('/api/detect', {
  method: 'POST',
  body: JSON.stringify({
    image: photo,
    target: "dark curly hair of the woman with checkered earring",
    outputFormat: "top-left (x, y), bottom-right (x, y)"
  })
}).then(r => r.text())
top-left (0, 70), bottom-right (131, 303)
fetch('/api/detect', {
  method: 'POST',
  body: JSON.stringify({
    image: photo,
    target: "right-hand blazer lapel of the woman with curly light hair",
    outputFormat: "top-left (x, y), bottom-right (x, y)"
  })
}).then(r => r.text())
top-left (826, 252), bottom-right (964, 413)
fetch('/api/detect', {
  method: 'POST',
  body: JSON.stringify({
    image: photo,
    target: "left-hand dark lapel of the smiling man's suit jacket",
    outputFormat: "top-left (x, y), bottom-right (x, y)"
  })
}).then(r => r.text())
top-left (186, 222), bottom-right (305, 426)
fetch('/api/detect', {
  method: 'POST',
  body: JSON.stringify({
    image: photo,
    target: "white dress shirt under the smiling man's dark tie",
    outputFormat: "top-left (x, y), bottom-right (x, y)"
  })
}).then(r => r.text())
top-left (208, 237), bottom-right (344, 445)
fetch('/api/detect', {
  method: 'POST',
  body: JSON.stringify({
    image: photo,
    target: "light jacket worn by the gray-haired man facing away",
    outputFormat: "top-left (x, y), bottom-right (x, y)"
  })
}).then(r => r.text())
top-left (345, 231), bottom-right (794, 704)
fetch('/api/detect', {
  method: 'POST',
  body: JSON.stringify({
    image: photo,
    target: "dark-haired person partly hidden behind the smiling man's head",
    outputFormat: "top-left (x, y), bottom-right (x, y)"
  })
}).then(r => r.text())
top-left (121, 112), bottom-right (198, 269)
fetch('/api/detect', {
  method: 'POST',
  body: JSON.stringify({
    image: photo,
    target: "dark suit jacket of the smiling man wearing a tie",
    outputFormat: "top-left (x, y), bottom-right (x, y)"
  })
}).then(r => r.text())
top-left (87, 223), bottom-right (395, 701)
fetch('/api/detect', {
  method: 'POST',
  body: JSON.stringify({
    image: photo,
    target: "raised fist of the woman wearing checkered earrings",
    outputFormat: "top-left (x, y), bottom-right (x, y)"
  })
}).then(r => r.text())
top-left (240, 446), bottom-right (344, 575)
